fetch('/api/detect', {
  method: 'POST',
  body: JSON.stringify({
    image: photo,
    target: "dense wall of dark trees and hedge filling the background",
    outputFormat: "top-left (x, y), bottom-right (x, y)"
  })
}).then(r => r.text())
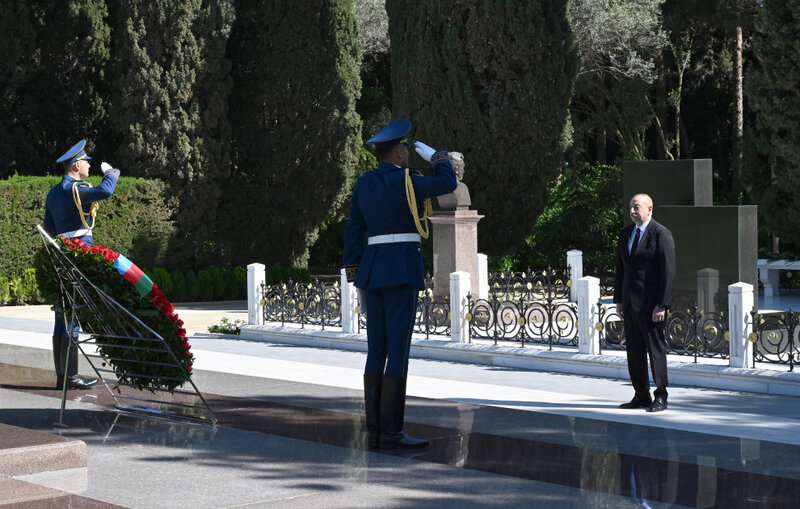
top-left (0, 0), bottom-right (800, 274)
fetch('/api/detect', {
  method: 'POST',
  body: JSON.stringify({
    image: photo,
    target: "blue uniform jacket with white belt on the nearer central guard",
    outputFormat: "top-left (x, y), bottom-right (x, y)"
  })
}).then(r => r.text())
top-left (343, 151), bottom-right (458, 289)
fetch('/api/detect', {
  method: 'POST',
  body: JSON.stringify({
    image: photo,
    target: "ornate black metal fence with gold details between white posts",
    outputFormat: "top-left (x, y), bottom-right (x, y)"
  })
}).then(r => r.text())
top-left (262, 268), bottom-right (756, 364)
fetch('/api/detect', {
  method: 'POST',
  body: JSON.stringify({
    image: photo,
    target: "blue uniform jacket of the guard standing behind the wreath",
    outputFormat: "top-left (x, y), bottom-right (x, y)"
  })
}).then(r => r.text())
top-left (42, 169), bottom-right (119, 241)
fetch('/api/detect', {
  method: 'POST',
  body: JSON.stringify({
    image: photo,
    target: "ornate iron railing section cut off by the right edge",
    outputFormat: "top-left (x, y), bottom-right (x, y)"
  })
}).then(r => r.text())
top-left (750, 308), bottom-right (800, 371)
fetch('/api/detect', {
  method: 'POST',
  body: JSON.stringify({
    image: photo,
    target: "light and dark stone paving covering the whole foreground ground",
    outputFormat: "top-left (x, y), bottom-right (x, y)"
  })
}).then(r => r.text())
top-left (0, 303), bottom-right (800, 508)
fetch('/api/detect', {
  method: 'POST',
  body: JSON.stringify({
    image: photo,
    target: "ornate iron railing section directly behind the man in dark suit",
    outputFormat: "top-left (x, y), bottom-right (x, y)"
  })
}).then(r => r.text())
top-left (595, 301), bottom-right (730, 362)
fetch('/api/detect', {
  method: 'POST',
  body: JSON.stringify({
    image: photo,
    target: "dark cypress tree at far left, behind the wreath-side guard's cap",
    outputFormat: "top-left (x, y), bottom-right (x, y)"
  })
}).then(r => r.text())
top-left (0, 0), bottom-right (111, 177)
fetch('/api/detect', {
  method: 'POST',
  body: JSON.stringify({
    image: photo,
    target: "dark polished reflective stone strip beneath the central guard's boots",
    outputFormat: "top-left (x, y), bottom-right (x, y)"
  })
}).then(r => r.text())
top-left (0, 365), bottom-right (800, 507)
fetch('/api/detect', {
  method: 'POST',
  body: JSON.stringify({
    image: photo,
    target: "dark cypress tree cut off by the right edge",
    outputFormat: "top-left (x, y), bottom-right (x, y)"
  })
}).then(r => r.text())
top-left (745, 0), bottom-right (800, 245)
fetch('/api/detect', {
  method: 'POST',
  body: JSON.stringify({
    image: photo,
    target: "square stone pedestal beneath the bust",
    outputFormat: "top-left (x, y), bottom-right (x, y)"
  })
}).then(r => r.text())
top-left (430, 210), bottom-right (483, 297)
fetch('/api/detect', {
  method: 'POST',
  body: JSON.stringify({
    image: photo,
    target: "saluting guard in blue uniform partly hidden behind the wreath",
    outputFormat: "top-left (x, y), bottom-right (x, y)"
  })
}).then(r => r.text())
top-left (42, 140), bottom-right (119, 389)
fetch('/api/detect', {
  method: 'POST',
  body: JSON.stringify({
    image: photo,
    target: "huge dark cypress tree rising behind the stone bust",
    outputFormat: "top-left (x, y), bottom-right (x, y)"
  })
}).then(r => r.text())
top-left (386, 0), bottom-right (577, 256)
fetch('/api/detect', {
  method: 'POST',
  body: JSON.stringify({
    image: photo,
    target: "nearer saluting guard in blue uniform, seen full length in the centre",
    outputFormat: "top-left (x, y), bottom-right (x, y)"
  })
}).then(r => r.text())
top-left (343, 119), bottom-right (458, 449)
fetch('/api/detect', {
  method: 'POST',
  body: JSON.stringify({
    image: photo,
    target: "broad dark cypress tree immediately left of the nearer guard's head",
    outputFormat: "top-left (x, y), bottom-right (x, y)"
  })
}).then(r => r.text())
top-left (219, 0), bottom-right (361, 266)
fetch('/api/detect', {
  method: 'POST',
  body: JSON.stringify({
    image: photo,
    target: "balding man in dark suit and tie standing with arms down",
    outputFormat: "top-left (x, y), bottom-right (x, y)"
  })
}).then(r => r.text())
top-left (614, 194), bottom-right (675, 412)
